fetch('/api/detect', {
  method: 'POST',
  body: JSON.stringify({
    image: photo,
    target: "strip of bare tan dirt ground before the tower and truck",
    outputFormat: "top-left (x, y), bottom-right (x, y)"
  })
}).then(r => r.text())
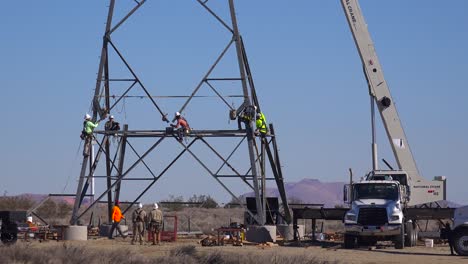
top-left (22, 238), bottom-right (468, 264)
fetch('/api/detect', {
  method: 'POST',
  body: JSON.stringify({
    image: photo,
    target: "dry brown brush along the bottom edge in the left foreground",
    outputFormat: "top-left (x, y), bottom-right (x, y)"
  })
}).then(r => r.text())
top-left (0, 243), bottom-right (336, 264)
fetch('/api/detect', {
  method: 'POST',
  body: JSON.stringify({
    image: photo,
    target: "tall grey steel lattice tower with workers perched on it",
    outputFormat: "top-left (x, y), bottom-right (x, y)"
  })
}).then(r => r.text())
top-left (70, 0), bottom-right (291, 225)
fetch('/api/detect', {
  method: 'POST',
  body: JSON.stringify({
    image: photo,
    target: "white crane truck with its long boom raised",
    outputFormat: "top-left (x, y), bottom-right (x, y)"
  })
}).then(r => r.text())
top-left (341, 0), bottom-right (468, 255)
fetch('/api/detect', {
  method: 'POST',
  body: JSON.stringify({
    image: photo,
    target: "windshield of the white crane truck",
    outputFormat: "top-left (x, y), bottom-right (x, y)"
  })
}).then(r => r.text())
top-left (354, 183), bottom-right (398, 201)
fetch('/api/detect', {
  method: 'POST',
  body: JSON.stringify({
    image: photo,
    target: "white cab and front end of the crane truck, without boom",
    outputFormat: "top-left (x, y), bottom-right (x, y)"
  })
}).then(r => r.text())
top-left (343, 171), bottom-right (417, 248)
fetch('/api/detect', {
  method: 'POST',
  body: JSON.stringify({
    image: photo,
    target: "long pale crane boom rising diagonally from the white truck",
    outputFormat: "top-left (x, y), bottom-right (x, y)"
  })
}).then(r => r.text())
top-left (341, 0), bottom-right (445, 205)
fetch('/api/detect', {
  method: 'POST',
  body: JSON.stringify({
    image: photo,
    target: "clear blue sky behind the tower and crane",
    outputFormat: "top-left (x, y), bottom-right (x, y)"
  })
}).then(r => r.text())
top-left (0, 0), bottom-right (468, 204)
